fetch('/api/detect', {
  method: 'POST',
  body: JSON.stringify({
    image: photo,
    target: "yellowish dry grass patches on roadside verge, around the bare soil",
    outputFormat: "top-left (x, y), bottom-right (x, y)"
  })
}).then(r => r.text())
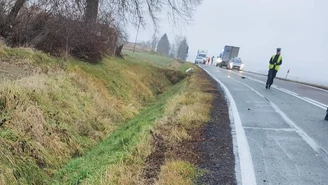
top-left (86, 70), bottom-right (212, 185)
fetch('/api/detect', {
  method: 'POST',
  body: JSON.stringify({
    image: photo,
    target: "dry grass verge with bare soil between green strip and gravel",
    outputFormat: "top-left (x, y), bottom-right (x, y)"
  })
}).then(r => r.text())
top-left (92, 70), bottom-right (212, 185)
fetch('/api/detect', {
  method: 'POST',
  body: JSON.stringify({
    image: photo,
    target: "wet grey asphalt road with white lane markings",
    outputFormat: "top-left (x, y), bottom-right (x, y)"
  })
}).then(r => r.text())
top-left (201, 65), bottom-right (328, 185)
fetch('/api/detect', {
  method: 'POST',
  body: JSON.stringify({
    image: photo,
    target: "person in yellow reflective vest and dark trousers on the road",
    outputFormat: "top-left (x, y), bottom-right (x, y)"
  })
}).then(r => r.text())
top-left (265, 48), bottom-right (282, 89)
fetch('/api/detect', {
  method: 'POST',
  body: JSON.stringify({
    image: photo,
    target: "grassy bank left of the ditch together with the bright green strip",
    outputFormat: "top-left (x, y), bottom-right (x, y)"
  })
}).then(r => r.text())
top-left (0, 47), bottom-right (190, 184)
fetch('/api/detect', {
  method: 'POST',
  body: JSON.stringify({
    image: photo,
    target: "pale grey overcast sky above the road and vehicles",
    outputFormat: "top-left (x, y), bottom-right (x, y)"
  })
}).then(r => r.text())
top-left (128, 0), bottom-right (328, 86)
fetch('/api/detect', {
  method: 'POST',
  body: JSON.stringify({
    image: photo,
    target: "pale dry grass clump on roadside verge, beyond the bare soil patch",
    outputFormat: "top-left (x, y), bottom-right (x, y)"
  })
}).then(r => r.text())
top-left (157, 73), bottom-right (212, 144)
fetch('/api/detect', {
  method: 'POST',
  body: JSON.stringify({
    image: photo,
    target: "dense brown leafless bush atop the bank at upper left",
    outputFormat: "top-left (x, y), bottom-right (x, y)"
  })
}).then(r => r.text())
top-left (0, 0), bottom-right (123, 63)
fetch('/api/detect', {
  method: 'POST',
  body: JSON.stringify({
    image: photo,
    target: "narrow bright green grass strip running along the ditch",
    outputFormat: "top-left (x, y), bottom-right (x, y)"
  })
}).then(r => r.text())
top-left (54, 81), bottom-right (186, 184)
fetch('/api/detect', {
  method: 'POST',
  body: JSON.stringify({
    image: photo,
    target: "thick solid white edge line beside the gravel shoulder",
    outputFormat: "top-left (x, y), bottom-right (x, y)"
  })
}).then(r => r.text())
top-left (203, 68), bottom-right (256, 185)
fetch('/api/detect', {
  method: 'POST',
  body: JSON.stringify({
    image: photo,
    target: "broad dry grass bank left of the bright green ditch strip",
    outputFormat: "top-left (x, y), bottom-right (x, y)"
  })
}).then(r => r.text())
top-left (0, 45), bottom-right (179, 184)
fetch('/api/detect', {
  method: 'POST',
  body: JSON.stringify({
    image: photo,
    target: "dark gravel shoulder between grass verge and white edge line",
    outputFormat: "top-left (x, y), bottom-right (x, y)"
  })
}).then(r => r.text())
top-left (197, 77), bottom-right (236, 185)
